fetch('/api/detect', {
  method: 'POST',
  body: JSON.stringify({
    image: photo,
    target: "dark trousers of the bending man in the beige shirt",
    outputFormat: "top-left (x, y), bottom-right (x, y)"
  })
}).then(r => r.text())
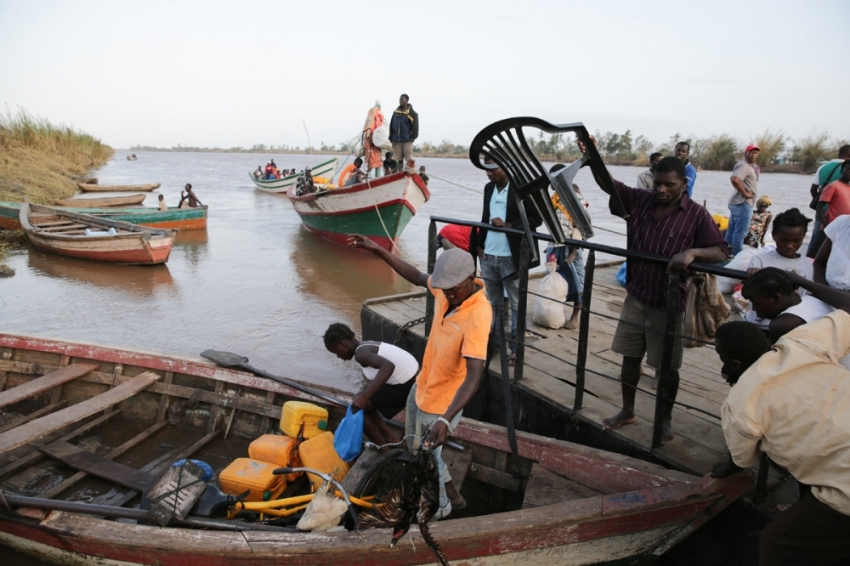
top-left (759, 493), bottom-right (850, 566)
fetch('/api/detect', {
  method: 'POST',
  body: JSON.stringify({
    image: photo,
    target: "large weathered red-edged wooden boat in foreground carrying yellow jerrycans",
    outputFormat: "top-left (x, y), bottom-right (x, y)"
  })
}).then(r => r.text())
top-left (0, 334), bottom-right (752, 566)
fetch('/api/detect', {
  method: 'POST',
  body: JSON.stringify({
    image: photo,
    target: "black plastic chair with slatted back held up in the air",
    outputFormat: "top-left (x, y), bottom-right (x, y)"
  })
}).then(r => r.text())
top-left (469, 117), bottom-right (628, 260)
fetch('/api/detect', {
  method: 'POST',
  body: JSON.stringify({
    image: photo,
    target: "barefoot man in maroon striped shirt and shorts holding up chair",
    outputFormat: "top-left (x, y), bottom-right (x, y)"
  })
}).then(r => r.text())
top-left (584, 151), bottom-right (729, 440)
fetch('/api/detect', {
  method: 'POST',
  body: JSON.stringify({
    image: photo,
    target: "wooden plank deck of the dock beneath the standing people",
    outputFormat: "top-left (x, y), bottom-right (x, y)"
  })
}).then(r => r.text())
top-left (361, 266), bottom-right (744, 475)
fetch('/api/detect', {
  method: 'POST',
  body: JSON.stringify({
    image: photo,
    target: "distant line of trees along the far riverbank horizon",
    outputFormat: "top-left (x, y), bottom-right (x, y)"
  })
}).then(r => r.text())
top-left (130, 129), bottom-right (850, 172)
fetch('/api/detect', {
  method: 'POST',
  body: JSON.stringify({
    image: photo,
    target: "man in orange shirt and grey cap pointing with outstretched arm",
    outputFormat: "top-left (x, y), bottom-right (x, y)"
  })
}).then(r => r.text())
top-left (348, 234), bottom-right (493, 519)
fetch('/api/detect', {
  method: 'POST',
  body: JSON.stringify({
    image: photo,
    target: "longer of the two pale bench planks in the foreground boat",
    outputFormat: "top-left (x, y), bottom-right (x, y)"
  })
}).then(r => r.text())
top-left (0, 371), bottom-right (160, 460)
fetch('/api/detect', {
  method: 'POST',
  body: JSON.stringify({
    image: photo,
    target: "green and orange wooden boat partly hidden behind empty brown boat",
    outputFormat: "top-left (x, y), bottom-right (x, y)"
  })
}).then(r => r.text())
top-left (0, 203), bottom-right (208, 230)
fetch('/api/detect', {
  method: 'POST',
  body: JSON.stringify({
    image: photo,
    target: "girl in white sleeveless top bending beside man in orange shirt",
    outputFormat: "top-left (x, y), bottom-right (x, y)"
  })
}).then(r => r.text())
top-left (324, 322), bottom-right (419, 451)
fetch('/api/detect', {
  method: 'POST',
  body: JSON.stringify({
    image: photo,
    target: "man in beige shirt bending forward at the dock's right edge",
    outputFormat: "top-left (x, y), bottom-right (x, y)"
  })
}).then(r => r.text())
top-left (711, 277), bottom-right (850, 566)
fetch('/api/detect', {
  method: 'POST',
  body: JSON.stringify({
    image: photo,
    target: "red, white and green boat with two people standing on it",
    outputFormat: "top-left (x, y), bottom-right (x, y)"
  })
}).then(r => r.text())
top-left (288, 172), bottom-right (431, 250)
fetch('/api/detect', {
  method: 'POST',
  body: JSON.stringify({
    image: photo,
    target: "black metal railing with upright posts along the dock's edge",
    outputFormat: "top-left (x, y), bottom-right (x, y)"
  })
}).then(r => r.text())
top-left (425, 216), bottom-right (747, 450)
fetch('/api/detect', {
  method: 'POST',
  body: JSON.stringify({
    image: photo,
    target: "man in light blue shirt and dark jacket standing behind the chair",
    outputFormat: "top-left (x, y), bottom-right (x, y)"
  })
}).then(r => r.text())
top-left (470, 159), bottom-right (543, 365)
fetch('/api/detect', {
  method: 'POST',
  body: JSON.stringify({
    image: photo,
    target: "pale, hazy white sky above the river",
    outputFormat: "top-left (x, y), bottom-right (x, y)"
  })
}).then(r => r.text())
top-left (0, 0), bottom-right (850, 148)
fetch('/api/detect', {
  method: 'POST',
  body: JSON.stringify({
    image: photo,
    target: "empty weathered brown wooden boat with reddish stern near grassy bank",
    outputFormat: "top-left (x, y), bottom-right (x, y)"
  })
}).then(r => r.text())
top-left (19, 201), bottom-right (177, 265)
